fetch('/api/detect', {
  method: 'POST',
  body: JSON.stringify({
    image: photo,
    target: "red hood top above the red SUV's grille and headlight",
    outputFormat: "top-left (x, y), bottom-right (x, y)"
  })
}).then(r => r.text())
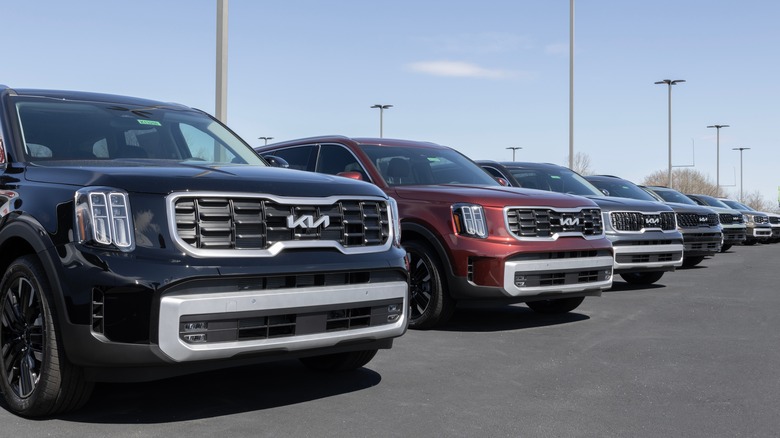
top-left (394, 185), bottom-right (597, 208)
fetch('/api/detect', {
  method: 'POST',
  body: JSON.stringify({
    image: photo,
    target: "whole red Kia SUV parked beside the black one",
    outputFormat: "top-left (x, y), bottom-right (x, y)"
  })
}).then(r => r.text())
top-left (257, 136), bottom-right (614, 328)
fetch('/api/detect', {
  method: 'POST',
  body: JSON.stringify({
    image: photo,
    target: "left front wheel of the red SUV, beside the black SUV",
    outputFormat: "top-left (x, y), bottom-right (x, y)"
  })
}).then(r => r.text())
top-left (403, 240), bottom-right (455, 329)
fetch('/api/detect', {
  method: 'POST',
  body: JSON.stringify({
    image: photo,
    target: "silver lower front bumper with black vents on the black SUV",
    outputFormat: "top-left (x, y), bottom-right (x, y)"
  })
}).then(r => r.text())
top-left (158, 282), bottom-right (409, 362)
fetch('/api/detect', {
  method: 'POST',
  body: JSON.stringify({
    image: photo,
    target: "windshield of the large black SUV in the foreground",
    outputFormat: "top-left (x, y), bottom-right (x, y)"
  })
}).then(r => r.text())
top-left (14, 97), bottom-right (264, 165)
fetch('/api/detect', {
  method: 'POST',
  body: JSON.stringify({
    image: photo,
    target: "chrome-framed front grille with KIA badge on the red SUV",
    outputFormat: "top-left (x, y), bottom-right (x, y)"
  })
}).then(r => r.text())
top-left (504, 207), bottom-right (604, 239)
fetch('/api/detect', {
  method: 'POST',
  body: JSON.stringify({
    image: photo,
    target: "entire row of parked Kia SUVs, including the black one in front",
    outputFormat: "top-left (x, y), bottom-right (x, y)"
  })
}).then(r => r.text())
top-left (0, 85), bottom-right (780, 417)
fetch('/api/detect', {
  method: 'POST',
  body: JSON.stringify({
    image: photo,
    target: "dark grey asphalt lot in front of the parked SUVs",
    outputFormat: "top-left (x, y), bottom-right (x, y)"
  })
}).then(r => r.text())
top-left (0, 244), bottom-right (780, 437)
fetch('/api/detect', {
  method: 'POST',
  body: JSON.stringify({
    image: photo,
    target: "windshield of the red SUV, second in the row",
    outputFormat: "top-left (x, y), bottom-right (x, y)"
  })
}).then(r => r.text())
top-left (361, 145), bottom-right (500, 186)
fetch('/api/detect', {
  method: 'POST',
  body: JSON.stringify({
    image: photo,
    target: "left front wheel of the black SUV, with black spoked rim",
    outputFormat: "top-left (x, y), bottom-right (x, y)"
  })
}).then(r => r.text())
top-left (0, 256), bottom-right (93, 417)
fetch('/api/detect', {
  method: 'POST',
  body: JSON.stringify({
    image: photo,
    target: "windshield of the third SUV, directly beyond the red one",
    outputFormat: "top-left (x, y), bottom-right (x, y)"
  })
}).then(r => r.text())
top-left (509, 166), bottom-right (604, 196)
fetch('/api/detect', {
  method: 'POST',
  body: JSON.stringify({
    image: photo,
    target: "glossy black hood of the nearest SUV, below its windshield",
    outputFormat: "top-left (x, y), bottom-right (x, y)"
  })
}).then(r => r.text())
top-left (25, 160), bottom-right (385, 197)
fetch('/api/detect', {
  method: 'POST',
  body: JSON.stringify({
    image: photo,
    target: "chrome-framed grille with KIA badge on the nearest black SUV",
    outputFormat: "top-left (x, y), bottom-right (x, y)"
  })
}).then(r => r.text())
top-left (166, 192), bottom-right (393, 257)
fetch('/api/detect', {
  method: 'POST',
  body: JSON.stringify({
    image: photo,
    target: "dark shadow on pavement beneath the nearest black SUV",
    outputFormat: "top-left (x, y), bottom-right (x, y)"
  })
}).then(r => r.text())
top-left (58, 360), bottom-right (382, 424)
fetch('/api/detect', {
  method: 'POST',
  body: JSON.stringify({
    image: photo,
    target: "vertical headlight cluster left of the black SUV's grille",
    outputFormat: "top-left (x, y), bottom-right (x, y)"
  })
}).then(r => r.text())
top-left (75, 187), bottom-right (135, 251)
